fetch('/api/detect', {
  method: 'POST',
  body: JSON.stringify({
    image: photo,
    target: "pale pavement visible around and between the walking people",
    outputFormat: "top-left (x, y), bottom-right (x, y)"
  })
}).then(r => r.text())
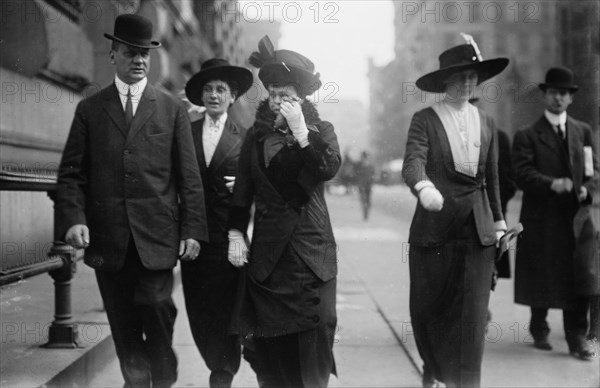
top-left (0, 186), bottom-right (600, 388)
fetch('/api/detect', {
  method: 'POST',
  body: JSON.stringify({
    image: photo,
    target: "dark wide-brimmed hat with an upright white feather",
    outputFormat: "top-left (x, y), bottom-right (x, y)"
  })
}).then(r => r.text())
top-left (417, 34), bottom-right (509, 93)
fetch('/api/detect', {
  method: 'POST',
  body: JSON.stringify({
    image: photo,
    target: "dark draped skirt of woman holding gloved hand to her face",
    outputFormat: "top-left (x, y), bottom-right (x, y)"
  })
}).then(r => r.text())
top-left (233, 246), bottom-right (337, 387)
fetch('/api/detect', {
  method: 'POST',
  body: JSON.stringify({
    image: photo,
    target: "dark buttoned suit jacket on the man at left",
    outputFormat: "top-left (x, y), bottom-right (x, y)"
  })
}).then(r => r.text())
top-left (55, 84), bottom-right (208, 270)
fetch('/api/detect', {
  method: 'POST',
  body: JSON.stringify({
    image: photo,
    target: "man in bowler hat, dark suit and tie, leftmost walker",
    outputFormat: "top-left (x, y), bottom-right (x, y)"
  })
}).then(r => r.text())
top-left (55, 14), bottom-right (208, 387)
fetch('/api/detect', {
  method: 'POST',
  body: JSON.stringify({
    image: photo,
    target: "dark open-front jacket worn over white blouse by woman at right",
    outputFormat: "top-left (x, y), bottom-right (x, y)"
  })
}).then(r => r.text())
top-left (402, 108), bottom-right (504, 247)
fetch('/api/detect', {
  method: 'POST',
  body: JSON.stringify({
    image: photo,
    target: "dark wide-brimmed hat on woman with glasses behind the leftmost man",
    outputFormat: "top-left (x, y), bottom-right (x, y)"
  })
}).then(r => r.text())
top-left (185, 58), bottom-right (253, 106)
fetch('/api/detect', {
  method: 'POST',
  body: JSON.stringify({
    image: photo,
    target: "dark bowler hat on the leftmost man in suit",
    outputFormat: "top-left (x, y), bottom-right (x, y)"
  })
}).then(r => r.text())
top-left (104, 14), bottom-right (160, 49)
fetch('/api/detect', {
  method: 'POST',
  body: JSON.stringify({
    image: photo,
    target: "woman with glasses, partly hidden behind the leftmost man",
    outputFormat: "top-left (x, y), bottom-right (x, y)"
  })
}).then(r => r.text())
top-left (181, 58), bottom-right (253, 387)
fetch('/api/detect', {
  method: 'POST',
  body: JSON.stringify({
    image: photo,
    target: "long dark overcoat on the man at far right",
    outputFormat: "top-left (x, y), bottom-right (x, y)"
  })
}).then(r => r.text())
top-left (512, 116), bottom-right (599, 308)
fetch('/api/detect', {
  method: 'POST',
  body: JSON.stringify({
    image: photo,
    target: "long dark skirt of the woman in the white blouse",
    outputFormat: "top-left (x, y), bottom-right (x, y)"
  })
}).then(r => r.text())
top-left (409, 218), bottom-right (496, 387)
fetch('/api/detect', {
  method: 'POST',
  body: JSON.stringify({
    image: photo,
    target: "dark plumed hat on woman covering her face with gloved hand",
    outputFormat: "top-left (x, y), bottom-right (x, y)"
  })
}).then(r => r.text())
top-left (248, 35), bottom-right (321, 96)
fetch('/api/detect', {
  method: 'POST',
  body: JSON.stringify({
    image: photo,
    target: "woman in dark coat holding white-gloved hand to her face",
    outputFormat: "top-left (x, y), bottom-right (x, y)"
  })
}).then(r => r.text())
top-left (229, 37), bottom-right (341, 387)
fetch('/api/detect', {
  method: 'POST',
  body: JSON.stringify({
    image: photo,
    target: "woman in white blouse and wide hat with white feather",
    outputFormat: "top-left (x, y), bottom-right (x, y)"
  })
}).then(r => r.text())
top-left (403, 35), bottom-right (508, 387)
